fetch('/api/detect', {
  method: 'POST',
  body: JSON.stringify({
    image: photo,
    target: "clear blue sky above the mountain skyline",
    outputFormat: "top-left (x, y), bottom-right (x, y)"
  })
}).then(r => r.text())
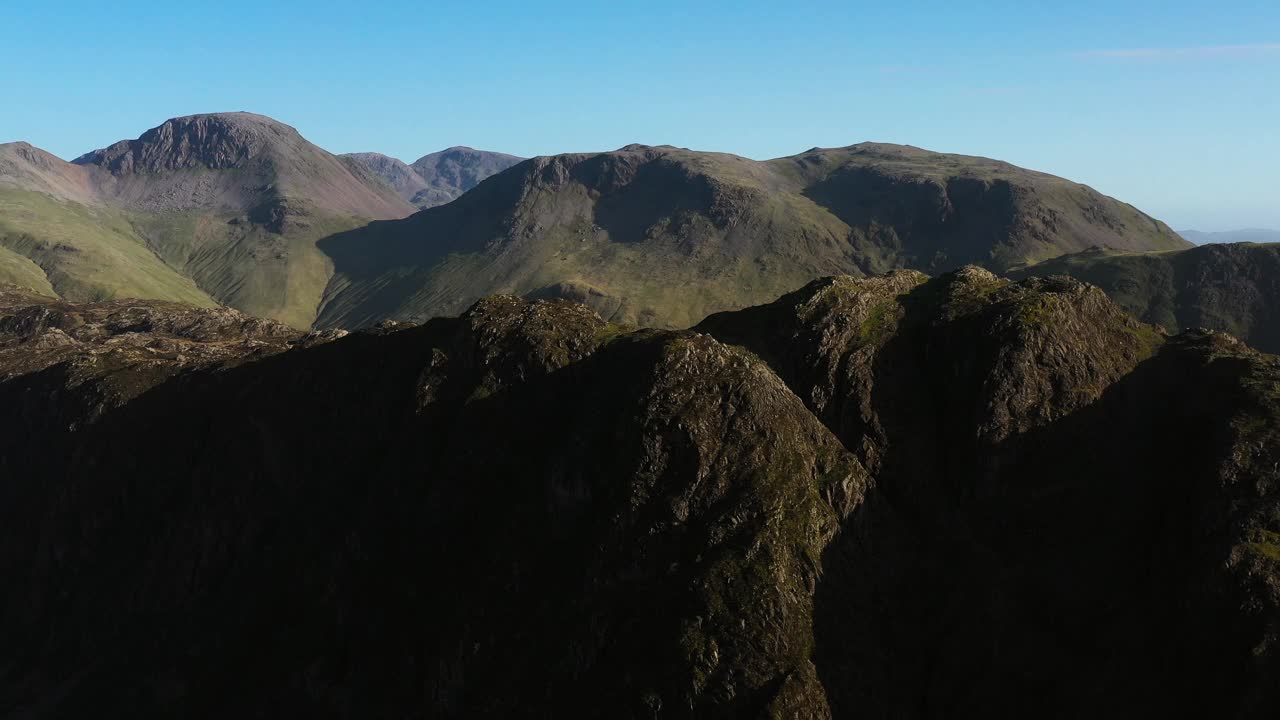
top-left (0, 0), bottom-right (1280, 229)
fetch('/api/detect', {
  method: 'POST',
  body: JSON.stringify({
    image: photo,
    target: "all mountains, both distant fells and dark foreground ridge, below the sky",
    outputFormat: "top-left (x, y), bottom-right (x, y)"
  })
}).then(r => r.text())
top-left (0, 106), bottom-right (1280, 720)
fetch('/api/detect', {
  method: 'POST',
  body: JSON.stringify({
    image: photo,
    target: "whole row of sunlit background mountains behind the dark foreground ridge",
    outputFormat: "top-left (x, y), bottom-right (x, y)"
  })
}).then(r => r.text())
top-left (0, 113), bottom-right (1190, 328)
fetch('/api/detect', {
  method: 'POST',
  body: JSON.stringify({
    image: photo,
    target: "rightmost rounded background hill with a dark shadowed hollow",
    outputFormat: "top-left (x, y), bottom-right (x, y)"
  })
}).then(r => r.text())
top-left (772, 142), bottom-right (1189, 269)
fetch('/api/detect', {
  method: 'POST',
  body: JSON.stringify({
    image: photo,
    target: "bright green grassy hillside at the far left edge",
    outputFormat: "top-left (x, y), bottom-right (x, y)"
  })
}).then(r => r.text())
top-left (0, 190), bottom-right (216, 306)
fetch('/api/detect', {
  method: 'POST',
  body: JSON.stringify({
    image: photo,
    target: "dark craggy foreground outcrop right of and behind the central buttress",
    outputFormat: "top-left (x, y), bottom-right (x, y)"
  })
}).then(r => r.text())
top-left (700, 270), bottom-right (1280, 717)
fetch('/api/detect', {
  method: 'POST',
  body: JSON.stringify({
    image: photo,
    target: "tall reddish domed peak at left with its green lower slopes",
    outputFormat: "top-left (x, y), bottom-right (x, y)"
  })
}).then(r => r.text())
top-left (0, 113), bottom-right (519, 328)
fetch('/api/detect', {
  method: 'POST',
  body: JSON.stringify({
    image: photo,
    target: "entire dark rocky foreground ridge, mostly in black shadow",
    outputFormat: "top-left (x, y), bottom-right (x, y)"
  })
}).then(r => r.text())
top-left (0, 268), bottom-right (1280, 717)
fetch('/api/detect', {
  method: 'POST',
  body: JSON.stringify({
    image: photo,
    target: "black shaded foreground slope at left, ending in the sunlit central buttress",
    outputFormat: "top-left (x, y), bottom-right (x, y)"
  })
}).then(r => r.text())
top-left (0, 284), bottom-right (863, 717)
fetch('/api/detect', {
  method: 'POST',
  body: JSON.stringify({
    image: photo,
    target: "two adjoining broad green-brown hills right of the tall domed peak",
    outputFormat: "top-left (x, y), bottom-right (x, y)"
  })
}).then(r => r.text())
top-left (317, 145), bottom-right (1188, 327)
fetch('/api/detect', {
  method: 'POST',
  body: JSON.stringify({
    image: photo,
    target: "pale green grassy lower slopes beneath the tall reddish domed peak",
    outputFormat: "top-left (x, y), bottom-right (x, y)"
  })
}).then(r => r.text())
top-left (0, 191), bottom-right (376, 328)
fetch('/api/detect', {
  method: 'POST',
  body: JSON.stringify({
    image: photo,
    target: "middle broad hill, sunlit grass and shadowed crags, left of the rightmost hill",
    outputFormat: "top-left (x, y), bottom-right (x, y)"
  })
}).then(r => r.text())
top-left (317, 150), bottom-right (859, 327)
